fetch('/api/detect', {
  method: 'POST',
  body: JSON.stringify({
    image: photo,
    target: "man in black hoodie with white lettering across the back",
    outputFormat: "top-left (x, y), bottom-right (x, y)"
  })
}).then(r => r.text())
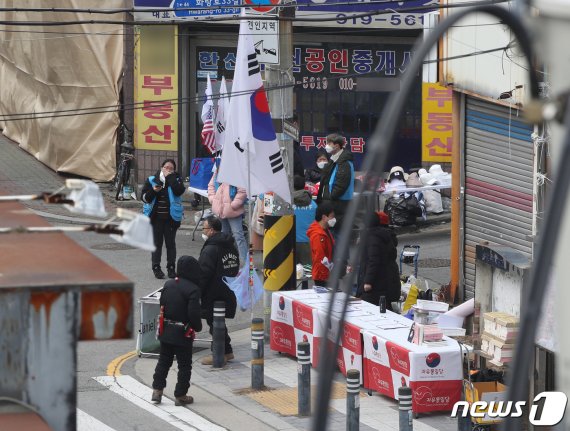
top-left (198, 216), bottom-right (239, 365)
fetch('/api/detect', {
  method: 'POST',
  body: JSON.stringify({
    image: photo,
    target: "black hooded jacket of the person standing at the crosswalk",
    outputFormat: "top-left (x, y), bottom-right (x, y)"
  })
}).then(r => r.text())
top-left (160, 256), bottom-right (202, 345)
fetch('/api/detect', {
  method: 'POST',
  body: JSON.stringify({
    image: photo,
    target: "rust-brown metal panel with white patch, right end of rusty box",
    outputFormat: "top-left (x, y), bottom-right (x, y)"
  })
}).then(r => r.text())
top-left (79, 290), bottom-right (133, 340)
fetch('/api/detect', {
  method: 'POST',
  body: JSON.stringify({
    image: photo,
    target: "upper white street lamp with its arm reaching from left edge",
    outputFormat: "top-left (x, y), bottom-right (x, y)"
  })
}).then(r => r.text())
top-left (0, 179), bottom-right (107, 217)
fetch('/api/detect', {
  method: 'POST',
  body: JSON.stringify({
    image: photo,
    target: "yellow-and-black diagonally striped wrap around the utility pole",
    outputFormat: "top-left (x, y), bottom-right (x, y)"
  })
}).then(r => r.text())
top-left (263, 215), bottom-right (297, 292)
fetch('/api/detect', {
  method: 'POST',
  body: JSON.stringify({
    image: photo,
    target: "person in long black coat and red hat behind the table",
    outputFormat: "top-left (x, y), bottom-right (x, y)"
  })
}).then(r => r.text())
top-left (356, 212), bottom-right (402, 310)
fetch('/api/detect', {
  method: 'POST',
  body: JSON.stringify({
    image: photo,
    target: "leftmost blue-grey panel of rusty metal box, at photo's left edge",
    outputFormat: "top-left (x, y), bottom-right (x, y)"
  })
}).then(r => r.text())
top-left (0, 291), bottom-right (29, 400)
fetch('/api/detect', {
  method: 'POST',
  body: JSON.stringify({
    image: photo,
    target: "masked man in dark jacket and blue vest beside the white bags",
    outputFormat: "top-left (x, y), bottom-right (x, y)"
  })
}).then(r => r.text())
top-left (317, 133), bottom-right (354, 235)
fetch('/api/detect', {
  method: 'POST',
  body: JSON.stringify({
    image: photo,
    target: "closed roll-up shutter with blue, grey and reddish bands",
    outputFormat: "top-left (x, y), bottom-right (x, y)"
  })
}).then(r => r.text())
top-left (463, 97), bottom-right (534, 298)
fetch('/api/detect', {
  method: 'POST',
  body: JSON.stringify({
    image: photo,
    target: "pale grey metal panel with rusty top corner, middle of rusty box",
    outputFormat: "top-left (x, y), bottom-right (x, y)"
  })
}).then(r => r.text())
top-left (23, 290), bottom-right (79, 430)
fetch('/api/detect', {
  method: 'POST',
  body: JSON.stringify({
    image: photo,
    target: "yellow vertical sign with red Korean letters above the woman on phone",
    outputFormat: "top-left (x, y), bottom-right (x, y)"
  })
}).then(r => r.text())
top-left (135, 25), bottom-right (179, 151)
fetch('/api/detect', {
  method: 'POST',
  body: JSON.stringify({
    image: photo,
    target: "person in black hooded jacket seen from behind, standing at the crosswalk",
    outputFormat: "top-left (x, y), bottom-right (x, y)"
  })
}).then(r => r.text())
top-left (152, 256), bottom-right (202, 406)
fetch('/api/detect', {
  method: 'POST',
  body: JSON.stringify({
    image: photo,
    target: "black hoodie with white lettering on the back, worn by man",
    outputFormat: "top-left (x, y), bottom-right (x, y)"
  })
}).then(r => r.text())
top-left (198, 232), bottom-right (239, 319)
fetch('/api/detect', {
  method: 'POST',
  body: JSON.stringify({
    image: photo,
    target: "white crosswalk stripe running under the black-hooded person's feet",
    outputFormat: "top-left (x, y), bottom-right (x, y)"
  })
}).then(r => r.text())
top-left (93, 376), bottom-right (225, 431)
